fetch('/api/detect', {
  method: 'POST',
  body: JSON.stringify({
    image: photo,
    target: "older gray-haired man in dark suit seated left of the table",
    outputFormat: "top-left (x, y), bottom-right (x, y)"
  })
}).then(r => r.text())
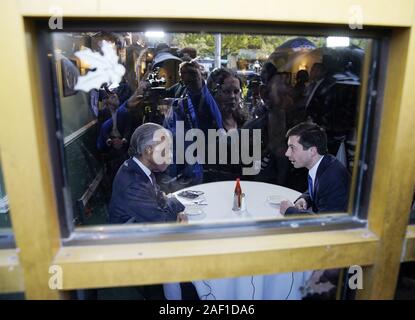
top-left (109, 123), bottom-right (186, 223)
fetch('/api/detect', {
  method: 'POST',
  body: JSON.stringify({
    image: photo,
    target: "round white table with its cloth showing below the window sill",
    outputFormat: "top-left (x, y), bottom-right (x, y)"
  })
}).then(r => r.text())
top-left (164, 181), bottom-right (311, 300)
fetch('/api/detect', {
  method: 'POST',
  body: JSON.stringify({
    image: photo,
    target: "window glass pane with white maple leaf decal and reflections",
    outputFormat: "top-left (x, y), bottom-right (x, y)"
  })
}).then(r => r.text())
top-left (51, 30), bottom-right (372, 225)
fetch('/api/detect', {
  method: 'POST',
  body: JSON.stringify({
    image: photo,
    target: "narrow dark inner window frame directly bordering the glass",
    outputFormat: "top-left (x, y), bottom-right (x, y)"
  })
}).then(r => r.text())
top-left (39, 19), bottom-right (389, 245)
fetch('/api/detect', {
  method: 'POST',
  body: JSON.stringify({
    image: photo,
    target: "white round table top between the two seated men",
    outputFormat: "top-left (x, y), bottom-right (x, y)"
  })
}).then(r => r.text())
top-left (174, 181), bottom-right (300, 223)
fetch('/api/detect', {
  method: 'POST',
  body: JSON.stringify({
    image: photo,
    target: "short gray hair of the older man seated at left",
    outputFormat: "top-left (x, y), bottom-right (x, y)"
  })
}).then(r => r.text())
top-left (128, 122), bottom-right (165, 157)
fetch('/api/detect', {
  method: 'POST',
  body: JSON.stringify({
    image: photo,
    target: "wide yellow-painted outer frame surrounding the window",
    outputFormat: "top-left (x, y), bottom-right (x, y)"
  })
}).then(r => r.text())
top-left (0, 0), bottom-right (415, 299)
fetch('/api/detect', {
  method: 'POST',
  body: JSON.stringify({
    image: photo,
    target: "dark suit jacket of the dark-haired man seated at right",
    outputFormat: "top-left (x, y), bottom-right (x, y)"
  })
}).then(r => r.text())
top-left (286, 155), bottom-right (350, 214)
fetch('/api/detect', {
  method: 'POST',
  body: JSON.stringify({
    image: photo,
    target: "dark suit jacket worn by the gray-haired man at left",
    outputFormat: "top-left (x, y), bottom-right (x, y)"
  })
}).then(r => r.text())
top-left (109, 158), bottom-right (184, 223)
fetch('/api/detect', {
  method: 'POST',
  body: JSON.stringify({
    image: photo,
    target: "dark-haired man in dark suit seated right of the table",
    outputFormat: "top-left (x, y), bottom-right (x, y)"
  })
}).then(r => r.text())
top-left (280, 122), bottom-right (350, 214)
